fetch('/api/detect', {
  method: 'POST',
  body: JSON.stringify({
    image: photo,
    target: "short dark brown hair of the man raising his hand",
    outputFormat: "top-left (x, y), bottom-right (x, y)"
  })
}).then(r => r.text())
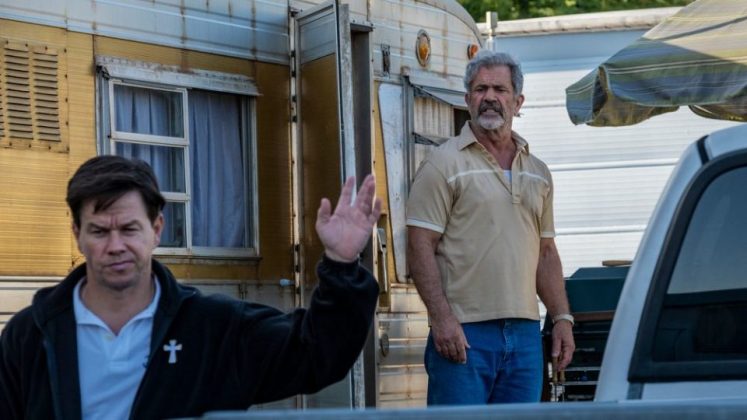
top-left (66, 155), bottom-right (166, 227)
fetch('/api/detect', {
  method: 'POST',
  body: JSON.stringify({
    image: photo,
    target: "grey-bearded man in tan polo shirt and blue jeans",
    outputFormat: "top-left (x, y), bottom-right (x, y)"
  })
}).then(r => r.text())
top-left (407, 50), bottom-right (575, 405)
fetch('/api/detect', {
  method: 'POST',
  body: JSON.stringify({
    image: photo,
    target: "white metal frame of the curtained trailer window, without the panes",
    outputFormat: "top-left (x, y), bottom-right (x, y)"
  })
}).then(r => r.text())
top-left (95, 57), bottom-right (260, 259)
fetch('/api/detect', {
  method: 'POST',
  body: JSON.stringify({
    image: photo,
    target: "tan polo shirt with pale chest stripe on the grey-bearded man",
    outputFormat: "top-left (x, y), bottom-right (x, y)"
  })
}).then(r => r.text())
top-left (407, 123), bottom-right (555, 323)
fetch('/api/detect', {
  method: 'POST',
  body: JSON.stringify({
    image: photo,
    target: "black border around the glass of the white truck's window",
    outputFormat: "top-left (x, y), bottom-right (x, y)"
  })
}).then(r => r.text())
top-left (628, 149), bottom-right (747, 383)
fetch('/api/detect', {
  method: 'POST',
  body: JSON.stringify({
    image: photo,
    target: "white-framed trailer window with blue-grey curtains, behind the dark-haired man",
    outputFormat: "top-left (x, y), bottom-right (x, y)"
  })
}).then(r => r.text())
top-left (99, 66), bottom-right (257, 256)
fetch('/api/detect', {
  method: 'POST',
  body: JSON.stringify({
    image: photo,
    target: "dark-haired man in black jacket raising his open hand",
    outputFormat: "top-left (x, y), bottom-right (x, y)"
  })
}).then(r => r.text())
top-left (0, 156), bottom-right (381, 420)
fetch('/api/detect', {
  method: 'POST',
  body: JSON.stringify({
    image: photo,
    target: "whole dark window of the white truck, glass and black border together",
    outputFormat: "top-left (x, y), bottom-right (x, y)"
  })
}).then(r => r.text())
top-left (629, 158), bottom-right (747, 382)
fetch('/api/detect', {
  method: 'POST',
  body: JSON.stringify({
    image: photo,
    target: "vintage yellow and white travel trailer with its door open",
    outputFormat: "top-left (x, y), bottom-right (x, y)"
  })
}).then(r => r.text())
top-left (0, 0), bottom-right (482, 407)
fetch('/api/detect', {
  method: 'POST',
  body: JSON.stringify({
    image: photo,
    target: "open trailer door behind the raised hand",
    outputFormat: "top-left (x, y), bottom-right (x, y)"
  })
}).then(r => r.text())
top-left (293, 1), bottom-right (371, 408)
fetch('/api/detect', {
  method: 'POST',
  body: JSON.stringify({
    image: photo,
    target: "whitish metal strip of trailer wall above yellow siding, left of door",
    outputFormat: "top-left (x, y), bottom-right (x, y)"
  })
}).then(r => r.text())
top-left (0, 0), bottom-right (289, 64)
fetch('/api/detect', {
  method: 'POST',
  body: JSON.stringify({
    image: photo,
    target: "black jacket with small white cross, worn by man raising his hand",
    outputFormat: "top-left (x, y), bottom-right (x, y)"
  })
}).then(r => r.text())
top-left (0, 258), bottom-right (378, 420)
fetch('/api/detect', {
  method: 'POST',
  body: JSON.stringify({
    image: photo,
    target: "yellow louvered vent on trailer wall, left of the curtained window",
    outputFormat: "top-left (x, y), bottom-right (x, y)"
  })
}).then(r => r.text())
top-left (0, 41), bottom-right (60, 142)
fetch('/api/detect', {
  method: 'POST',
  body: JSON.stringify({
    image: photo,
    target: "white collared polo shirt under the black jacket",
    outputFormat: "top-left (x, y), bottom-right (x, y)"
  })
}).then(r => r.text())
top-left (73, 278), bottom-right (161, 419)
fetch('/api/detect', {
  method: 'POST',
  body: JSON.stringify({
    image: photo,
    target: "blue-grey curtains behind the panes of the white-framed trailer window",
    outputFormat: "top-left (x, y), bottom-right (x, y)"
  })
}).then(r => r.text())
top-left (115, 85), bottom-right (248, 247)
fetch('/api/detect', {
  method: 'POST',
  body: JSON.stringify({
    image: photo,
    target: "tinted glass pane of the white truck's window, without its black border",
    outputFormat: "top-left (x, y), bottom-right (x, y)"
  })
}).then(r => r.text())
top-left (653, 168), bottom-right (747, 361)
